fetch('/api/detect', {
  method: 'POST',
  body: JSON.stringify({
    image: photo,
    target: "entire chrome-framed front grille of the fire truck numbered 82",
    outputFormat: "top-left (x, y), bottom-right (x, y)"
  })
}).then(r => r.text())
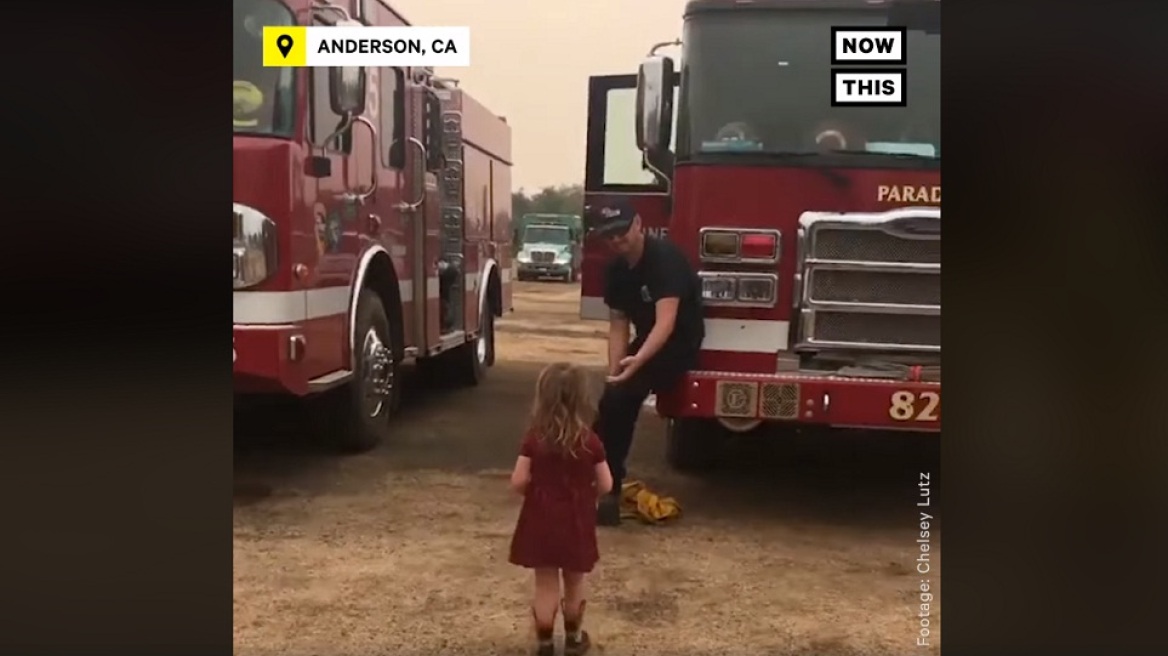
top-left (797, 208), bottom-right (941, 353)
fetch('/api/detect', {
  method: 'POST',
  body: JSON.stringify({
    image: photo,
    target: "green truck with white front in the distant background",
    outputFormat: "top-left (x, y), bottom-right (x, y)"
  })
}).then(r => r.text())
top-left (514, 214), bottom-right (584, 282)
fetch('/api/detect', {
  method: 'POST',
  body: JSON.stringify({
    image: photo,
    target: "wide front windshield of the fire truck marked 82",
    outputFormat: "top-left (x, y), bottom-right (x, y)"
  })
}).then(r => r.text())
top-left (677, 8), bottom-right (941, 168)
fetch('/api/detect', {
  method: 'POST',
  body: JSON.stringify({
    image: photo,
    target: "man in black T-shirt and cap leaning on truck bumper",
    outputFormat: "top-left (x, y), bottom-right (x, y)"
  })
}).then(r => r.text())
top-left (585, 200), bottom-right (705, 526)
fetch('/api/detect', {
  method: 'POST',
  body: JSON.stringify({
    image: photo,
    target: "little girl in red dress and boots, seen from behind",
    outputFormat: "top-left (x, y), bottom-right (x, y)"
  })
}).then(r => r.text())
top-left (510, 363), bottom-right (612, 656)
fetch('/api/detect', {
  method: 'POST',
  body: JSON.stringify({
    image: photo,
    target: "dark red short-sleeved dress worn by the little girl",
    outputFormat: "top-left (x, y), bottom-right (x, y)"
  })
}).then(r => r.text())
top-left (510, 433), bottom-right (605, 572)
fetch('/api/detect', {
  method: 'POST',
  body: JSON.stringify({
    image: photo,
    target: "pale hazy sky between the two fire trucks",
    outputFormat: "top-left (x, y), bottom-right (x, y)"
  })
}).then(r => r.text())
top-left (391, 0), bottom-right (686, 191)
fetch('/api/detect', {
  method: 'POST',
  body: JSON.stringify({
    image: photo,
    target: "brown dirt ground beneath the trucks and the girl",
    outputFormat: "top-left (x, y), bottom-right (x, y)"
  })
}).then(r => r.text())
top-left (234, 277), bottom-right (940, 656)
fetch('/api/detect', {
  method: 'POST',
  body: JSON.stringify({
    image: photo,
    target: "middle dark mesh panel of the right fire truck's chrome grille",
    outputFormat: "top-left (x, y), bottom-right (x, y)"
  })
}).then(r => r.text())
top-left (809, 268), bottom-right (941, 306)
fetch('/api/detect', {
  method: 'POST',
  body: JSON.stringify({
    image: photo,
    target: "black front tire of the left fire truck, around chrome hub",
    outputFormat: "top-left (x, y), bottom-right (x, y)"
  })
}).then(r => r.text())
top-left (314, 289), bottom-right (403, 453)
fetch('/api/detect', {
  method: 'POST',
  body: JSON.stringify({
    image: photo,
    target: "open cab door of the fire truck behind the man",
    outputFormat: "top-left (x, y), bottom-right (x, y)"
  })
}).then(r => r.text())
top-left (580, 75), bottom-right (677, 320)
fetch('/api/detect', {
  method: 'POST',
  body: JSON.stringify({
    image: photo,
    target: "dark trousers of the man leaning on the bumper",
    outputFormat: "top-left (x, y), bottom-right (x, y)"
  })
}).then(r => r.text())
top-left (593, 345), bottom-right (694, 494)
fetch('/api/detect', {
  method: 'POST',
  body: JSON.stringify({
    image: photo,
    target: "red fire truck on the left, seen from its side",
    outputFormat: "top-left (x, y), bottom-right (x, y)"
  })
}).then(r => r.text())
top-left (232, 0), bottom-right (512, 451)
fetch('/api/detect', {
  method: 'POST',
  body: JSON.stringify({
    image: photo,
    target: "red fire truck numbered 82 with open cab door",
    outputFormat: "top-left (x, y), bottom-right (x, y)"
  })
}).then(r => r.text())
top-left (580, 0), bottom-right (941, 469)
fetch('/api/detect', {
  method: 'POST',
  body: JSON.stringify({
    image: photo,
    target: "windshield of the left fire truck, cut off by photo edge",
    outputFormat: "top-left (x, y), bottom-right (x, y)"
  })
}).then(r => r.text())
top-left (231, 0), bottom-right (294, 138)
